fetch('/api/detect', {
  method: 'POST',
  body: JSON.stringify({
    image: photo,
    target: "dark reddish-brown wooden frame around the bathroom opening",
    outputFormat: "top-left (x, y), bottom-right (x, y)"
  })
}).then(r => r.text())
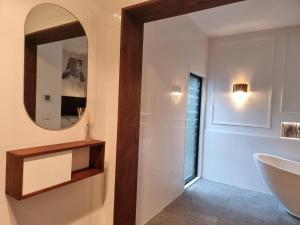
top-left (114, 0), bottom-right (244, 225)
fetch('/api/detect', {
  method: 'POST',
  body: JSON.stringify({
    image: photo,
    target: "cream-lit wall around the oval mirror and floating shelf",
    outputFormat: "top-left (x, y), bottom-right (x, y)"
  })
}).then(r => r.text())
top-left (0, 0), bottom-right (113, 225)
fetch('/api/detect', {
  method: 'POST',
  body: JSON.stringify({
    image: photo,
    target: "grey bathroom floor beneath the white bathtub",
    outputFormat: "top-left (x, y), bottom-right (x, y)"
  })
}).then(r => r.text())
top-left (147, 180), bottom-right (300, 225)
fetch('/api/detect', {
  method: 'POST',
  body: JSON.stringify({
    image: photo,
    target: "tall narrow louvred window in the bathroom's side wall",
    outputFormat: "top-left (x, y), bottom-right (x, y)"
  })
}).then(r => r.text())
top-left (184, 73), bottom-right (202, 185)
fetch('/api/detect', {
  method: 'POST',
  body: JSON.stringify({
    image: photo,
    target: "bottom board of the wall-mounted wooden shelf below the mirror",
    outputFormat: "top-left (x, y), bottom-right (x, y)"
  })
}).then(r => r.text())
top-left (18, 168), bottom-right (104, 200)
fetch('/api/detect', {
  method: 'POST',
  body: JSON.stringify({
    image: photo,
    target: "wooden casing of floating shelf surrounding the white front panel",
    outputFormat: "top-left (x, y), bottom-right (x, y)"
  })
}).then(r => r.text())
top-left (6, 140), bottom-right (105, 200)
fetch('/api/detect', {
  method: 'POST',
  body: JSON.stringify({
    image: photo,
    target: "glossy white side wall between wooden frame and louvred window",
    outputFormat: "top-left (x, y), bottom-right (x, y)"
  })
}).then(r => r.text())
top-left (137, 17), bottom-right (208, 225)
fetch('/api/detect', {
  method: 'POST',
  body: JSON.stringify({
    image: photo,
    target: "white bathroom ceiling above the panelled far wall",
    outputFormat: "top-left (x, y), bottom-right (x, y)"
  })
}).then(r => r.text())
top-left (188, 0), bottom-right (300, 37)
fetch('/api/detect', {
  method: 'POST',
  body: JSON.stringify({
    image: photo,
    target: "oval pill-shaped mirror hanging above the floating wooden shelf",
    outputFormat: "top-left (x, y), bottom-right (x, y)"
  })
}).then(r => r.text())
top-left (24, 4), bottom-right (88, 130)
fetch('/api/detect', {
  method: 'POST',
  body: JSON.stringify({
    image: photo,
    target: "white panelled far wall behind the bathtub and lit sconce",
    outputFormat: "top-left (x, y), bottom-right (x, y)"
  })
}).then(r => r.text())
top-left (203, 27), bottom-right (300, 193)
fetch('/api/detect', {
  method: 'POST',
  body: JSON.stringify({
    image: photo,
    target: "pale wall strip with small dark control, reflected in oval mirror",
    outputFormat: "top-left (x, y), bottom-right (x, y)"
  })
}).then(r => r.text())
top-left (36, 42), bottom-right (63, 130)
